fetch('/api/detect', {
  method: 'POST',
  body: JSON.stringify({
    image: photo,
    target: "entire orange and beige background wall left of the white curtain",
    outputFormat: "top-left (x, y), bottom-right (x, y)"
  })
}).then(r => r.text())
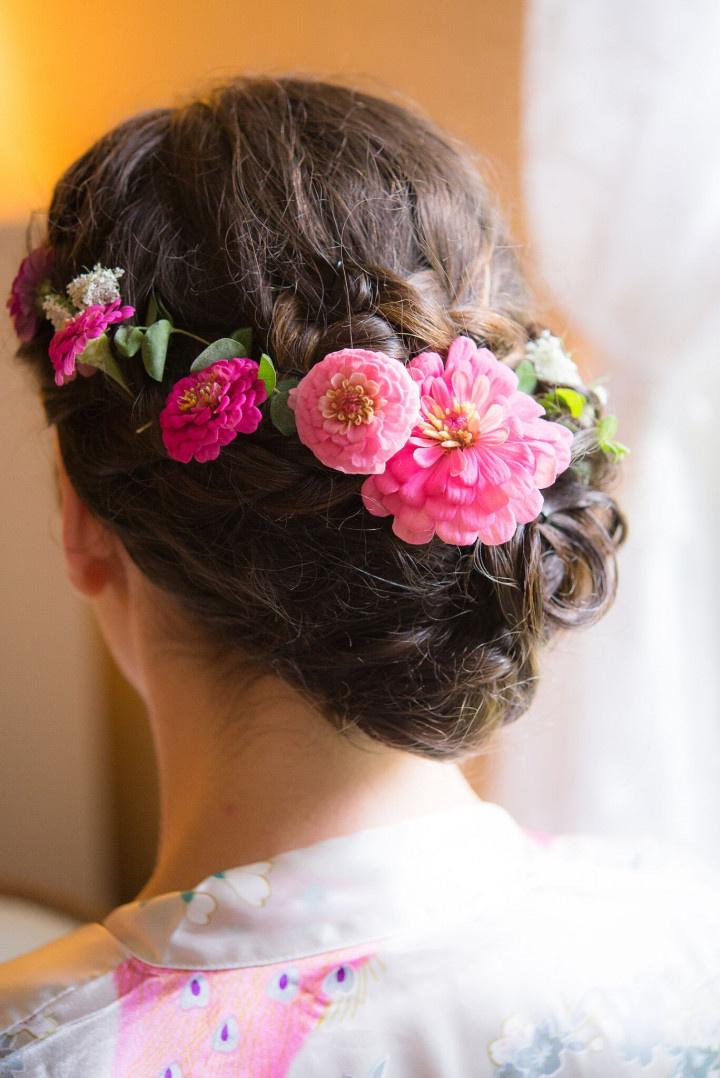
top-left (0, 0), bottom-right (523, 902)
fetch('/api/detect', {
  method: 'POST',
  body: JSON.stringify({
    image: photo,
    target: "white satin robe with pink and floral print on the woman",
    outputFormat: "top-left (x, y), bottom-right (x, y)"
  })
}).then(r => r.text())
top-left (0, 800), bottom-right (720, 1078)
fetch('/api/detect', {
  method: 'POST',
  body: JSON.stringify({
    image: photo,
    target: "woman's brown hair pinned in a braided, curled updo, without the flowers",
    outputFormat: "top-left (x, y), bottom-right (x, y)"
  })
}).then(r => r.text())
top-left (15, 79), bottom-right (624, 759)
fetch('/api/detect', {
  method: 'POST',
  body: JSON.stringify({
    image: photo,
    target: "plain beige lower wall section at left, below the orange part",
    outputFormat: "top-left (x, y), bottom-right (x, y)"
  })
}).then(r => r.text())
top-left (0, 227), bottom-right (113, 912)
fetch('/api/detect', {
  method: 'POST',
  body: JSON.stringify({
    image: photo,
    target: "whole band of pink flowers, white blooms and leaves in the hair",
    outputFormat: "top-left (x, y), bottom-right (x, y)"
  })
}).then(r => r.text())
top-left (8, 248), bottom-right (628, 545)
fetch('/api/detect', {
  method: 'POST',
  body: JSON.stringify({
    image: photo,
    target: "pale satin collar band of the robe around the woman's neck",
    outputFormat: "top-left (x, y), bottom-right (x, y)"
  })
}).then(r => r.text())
top-left (103, 799), bottom-right (530, 969)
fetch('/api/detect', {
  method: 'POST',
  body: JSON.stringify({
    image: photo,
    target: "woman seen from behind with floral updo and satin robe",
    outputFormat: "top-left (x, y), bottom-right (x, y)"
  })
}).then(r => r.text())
top-left (0, 79), bottom-right (720, 1078)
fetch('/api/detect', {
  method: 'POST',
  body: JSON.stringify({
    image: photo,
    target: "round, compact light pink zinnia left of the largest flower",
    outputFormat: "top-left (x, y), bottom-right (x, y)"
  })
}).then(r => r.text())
top-left (288, 348), bottom-right (420, 474)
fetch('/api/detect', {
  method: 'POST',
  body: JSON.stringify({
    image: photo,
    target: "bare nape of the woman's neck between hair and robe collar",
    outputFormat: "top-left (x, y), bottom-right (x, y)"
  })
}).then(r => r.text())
top-left (138, 629), bottom-right (479, 898)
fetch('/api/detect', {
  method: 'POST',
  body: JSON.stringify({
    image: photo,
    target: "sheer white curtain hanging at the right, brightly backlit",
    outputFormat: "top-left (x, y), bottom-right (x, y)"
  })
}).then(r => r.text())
top-left (482, 0), bottom-right (720, 858)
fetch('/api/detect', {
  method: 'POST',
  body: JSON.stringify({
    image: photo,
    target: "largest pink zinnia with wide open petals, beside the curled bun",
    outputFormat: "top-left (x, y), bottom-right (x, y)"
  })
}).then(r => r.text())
top-left (361, 337), bottom-right (572, 545)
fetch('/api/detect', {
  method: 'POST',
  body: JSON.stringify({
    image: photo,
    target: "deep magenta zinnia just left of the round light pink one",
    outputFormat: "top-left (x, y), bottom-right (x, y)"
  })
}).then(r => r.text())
top-left (160, 358), bottom-right (267, 465)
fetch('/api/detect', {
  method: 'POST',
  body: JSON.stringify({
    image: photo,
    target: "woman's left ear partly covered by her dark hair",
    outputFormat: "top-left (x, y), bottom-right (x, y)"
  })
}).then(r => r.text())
top-left (55, 442), bottom-right (119, 598)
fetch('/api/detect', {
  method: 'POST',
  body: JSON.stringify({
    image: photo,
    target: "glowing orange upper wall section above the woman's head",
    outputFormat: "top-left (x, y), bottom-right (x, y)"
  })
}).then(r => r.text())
top-left (0, 0), bottom-right (523, 219)
